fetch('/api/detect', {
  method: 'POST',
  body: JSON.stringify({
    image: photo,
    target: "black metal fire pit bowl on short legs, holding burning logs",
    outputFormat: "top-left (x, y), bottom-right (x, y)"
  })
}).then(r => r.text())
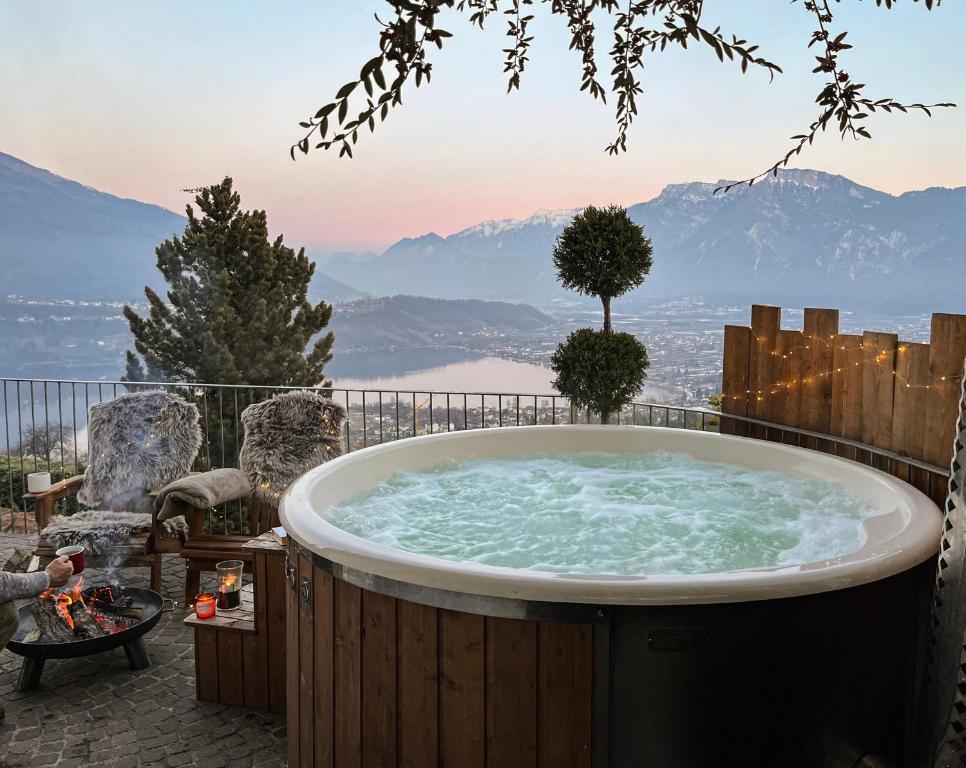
top-left (7, 585), bottom-right (164, 691)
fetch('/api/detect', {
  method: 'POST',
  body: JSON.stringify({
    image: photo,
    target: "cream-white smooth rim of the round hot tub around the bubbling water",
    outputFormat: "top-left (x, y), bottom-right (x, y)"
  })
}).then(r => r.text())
top-left (280, 425), bottom-right (942, 605)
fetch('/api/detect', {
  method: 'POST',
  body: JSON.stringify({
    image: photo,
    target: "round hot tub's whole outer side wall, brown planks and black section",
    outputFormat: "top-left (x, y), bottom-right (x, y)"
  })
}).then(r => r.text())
top-left (287, 543), bottom-right (931, 768)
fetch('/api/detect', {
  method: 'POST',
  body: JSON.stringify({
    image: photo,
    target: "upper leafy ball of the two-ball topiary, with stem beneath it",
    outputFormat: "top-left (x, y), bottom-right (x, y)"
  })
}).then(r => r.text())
top-left (553, 205), bottom-right (653, 331)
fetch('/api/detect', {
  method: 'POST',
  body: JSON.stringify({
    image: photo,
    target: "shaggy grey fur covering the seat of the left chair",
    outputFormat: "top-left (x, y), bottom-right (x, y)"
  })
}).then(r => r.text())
top-left (43, 509), bottom-right (187, 555)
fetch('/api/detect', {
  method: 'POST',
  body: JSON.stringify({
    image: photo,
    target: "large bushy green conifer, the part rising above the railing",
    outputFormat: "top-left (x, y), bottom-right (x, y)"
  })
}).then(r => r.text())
top-left (124, 178), bottom-right (334, 386)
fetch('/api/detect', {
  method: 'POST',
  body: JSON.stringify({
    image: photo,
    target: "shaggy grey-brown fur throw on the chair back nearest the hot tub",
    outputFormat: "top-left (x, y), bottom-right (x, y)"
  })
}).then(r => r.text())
top-left (239, 389), bottom-right (346, 506)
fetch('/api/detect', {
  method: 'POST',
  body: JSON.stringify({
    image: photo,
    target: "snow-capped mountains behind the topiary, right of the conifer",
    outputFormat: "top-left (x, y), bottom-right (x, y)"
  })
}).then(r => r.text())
top-left (326, 170), bottom-right (966, 311)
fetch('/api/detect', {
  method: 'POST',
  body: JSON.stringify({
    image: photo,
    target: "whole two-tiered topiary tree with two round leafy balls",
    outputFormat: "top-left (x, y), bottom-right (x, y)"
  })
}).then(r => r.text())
top-left (550, 206), bottom-right (652, 424)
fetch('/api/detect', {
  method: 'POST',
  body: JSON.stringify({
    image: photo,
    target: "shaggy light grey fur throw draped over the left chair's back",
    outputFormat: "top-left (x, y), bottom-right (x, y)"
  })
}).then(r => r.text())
top-left (78, 390), bottom-right (201, 512)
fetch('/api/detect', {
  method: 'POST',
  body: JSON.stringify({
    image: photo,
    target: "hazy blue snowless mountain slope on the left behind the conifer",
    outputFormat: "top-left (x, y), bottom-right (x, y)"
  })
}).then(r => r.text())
top-left (0, 152), bottom-right (368, 302)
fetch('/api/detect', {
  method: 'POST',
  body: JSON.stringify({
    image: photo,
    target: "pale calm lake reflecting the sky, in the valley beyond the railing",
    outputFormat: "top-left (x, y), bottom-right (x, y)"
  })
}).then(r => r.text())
top-left (326, 351), bottom-right (681, 402)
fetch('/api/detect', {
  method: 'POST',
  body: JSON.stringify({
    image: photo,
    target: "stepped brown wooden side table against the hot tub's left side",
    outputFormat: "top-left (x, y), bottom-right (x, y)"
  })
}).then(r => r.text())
top-left (184, 531), bottom-right (287, 713)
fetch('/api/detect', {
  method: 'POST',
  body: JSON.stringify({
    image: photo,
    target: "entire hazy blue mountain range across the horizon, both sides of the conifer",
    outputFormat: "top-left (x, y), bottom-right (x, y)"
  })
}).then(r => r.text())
top-left (0, 153), bottom-right (966, 311)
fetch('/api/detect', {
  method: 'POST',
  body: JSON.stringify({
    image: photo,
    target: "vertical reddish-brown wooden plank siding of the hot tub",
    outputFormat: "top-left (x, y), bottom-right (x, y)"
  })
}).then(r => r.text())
top-left (287, 547), bottom-right (593, 768)
